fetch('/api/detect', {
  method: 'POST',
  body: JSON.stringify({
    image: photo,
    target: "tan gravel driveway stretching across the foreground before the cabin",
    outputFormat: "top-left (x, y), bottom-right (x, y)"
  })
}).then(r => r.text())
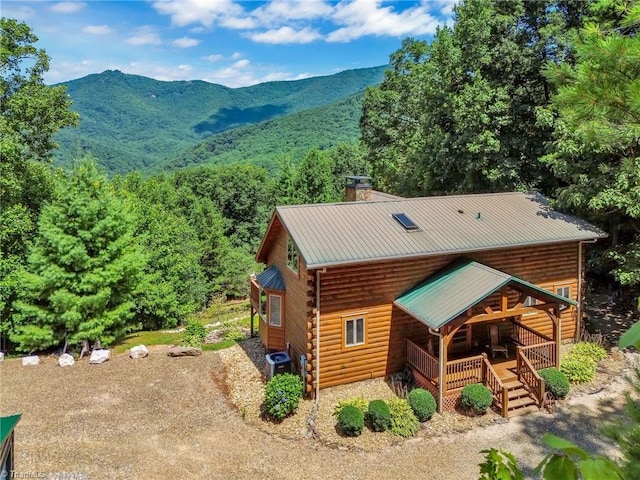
top-left (0, 347), bottom-right (624, 480)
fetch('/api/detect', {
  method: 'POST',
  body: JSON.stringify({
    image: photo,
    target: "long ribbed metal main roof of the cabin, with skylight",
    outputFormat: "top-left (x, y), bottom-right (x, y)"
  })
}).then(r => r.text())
top-left (268, 193), bottom-right (606, 269)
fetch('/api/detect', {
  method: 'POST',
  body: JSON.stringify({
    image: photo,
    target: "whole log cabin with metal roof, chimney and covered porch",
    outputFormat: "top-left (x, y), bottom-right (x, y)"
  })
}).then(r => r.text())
top-left (250, 177), bottom-right (606, 417)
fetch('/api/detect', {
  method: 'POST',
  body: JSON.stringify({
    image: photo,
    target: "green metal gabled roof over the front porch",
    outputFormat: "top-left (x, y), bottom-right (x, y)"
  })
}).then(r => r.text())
top-left (393, 260), bottom-right (577, 330)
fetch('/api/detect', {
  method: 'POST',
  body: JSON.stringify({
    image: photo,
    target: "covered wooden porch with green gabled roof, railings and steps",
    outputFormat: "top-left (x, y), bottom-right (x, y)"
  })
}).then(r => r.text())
top-left (394, 260), bottom-right (575, 417)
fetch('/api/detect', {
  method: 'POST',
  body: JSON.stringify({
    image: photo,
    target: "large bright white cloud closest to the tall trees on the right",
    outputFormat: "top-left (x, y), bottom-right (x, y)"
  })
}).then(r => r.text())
top-left (327, 0), bottom-right (443, 42)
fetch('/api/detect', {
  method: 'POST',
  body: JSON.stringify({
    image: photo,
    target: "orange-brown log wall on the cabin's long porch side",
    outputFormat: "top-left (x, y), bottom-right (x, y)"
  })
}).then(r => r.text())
top-left (314, 244), bottom-right (578, 388)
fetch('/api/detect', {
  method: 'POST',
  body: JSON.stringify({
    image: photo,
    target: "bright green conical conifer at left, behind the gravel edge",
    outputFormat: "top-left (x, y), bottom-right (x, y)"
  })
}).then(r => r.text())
top-left (11, 159), bottom-right (144, 352)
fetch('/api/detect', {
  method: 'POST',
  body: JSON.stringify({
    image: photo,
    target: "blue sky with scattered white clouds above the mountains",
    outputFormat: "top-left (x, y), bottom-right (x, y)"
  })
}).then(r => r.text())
top-left (5, 0), bottom-right (454, 87)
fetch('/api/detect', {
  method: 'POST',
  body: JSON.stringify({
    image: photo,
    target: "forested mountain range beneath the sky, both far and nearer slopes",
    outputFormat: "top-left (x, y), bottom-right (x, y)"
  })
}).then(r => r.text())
top-left (56, 66), bottom-right (387, 174)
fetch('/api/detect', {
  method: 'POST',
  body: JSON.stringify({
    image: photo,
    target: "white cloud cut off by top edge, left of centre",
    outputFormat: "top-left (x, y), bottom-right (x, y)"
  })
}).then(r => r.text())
top-left (153, 0), bottom-right (244, 27)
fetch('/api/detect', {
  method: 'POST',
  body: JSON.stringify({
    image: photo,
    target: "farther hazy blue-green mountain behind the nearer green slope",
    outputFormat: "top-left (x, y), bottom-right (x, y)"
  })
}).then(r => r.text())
top-left (56, 65), bottom-right (387, 174)
